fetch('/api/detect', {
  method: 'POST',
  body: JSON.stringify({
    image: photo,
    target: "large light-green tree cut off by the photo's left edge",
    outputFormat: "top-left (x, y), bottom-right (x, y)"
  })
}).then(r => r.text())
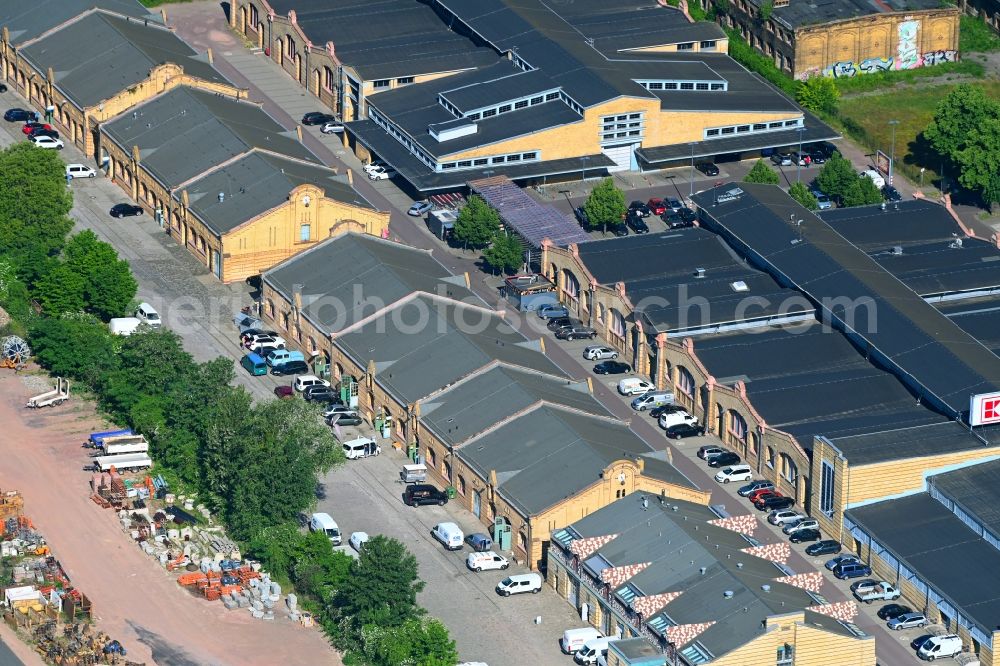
top-left (0, 143), bottom-right (73, 272)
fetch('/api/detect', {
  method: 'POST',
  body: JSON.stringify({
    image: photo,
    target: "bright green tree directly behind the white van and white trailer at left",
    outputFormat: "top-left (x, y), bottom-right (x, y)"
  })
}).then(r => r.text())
top-left (63, 229), bottom-right (139, 321)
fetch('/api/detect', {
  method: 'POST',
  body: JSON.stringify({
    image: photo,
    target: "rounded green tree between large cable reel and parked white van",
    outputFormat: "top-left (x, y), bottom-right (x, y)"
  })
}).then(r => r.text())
top-left (29, 315), bottom-right (117, 386)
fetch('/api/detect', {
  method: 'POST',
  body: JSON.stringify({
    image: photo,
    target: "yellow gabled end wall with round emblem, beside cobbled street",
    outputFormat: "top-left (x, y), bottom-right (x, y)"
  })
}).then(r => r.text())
top-left (222, 185), bottom-right (389, 283)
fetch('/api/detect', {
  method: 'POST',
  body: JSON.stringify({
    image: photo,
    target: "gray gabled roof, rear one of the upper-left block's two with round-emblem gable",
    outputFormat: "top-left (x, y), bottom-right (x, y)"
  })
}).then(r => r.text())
top-left (101, 86), bottom-right (312, 188)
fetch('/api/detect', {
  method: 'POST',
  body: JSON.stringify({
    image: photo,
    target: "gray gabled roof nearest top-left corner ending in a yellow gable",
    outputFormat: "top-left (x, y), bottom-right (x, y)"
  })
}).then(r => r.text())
top-left (21, 12), bottom-right (228, 109)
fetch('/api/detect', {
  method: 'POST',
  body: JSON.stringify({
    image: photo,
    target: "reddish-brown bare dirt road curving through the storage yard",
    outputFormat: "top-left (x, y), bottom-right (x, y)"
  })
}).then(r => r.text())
top-left (0, 370), bottom-right (341, 666)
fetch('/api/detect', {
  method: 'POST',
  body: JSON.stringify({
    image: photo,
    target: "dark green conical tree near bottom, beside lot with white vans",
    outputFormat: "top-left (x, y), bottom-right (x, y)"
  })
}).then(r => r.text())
top-left (336, 535), bottom-right (424, 629)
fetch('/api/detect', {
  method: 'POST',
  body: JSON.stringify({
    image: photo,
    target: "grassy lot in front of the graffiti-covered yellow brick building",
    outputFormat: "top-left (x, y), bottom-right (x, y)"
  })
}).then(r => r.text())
top-left (835, 79), bottom-right (1000, 185)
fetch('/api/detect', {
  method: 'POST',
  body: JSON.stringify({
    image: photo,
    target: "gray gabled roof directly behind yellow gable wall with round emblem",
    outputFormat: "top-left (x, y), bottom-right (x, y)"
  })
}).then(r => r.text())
top-left (181, 151), bottom-right (375, 235)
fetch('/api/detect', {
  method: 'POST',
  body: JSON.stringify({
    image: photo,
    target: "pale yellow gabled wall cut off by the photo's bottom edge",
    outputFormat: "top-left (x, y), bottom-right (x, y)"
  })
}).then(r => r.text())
top-left (712, 613), bottom-right (875, 666)
